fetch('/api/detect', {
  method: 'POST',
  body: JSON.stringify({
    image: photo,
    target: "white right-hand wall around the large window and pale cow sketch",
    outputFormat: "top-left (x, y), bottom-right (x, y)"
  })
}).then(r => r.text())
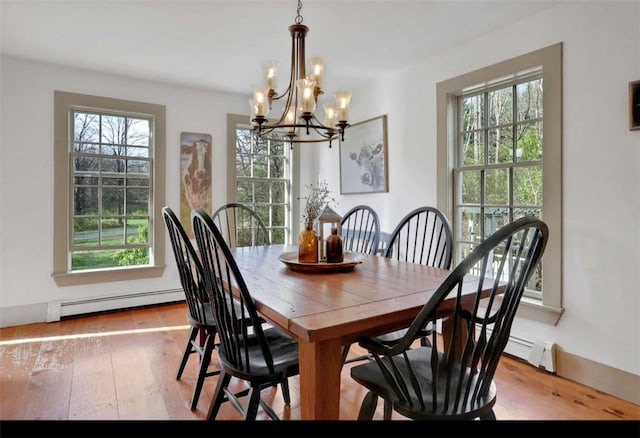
top-left (320, 1), bottom-right (640, 375)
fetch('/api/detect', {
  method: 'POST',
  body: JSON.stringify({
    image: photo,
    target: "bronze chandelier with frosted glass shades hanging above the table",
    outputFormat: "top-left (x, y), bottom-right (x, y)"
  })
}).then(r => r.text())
top-left (250, 0), bottom-right (351, 147)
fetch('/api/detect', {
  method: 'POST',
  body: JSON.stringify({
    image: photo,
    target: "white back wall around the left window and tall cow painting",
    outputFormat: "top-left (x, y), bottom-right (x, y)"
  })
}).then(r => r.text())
top-left (0, 57), bottom-right (248, 323)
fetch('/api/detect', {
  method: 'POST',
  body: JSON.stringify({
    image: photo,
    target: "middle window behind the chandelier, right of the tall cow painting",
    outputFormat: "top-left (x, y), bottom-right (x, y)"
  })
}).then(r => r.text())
top-left (228, 115), bottom-right (292, 244)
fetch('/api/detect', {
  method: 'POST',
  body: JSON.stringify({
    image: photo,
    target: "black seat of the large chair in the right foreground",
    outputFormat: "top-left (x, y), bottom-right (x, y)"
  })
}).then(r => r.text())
top-left (351, 347), bottom-right (496, 420)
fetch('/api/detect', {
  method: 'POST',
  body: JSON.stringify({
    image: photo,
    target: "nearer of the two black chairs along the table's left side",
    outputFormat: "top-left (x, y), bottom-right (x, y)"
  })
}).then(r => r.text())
top-left (191, 209), bottom-right (299, 420)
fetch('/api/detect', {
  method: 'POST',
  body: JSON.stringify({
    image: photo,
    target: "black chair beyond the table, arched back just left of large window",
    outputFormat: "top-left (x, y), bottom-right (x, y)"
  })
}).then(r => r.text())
top-left (343, 206), bottom-right (453, 363)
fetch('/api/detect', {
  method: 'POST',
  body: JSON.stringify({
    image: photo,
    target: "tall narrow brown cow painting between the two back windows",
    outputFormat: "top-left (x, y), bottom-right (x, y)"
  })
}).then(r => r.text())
top-left (180, 132), bottom-right (212, 238)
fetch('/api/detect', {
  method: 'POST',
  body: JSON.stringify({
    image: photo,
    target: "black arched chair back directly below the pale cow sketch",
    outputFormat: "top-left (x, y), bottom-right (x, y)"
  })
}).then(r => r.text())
top-left (340, 205), bottom-right (380, 254)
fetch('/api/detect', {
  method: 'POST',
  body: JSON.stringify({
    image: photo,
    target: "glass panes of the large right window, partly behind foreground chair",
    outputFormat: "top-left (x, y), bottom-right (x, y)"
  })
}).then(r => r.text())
top-left (454, 78), bottom-right (543, 297)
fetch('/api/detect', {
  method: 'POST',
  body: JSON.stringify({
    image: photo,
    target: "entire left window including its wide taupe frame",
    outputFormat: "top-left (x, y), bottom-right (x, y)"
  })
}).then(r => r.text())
top-left (54, 91), bottom-right (165, 285)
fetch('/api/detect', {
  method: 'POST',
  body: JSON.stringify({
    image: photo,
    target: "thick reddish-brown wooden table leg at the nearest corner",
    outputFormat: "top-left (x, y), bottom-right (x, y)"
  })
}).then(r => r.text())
top-left (298, 339), bottom-right (342, 420)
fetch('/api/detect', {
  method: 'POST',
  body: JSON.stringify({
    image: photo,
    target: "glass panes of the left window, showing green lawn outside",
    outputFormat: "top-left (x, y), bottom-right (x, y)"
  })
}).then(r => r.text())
top-left (71, 110), bottom-right (153, 271)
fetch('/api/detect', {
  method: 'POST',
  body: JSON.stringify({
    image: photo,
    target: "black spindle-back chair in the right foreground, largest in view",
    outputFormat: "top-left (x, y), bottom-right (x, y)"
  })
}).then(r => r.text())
top-left (351, 217), bottom-right (549, 420)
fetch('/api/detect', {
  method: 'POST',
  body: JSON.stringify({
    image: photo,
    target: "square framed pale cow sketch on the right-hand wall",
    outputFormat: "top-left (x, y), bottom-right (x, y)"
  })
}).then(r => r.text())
top-left (340, 114), bottom-right (389, 195)
